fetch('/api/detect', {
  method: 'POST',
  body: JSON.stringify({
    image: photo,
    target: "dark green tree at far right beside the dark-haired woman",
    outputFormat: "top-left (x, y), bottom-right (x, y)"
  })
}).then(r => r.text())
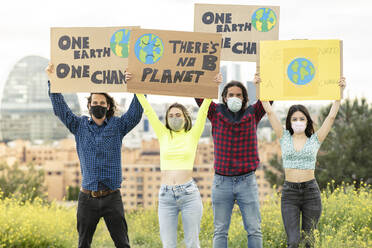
top-left (316, 98), bottom-right (372, 188)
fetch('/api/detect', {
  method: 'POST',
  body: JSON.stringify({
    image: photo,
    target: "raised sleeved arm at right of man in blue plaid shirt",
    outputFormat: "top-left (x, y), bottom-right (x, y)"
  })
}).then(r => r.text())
top-left (120, 95), bottom-right (143, 136)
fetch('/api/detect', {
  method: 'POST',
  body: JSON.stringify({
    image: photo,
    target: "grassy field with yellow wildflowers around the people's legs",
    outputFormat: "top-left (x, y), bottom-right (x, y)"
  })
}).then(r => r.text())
top-left (0, 183), bottom-right (372, 248)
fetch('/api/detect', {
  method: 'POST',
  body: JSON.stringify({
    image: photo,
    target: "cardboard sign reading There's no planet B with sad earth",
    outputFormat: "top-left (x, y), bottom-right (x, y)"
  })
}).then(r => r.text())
top-left (127, 29), bottom-right (222, 98)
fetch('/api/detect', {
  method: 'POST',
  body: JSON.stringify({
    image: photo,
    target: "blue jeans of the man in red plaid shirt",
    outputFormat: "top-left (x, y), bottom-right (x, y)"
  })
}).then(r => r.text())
top-left (212, 172), bottom-right (262, 248)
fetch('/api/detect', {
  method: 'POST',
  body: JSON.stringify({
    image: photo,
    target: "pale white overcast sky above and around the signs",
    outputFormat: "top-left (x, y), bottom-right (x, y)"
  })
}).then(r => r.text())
top-left (0, 0), bottom-right (372, 106)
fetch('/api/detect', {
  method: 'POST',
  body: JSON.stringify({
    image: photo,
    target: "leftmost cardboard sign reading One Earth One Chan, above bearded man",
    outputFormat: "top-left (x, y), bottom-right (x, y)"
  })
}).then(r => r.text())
top-left (50, 27), bottom-right (139, 92)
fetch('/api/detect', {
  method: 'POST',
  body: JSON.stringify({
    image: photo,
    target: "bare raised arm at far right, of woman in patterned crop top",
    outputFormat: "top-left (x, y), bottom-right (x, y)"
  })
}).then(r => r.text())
top-left (317, 77), bottom-right (346, 142)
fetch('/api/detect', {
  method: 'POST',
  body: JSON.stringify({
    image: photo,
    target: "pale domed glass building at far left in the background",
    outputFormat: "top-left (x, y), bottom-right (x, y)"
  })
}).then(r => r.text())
top-left (0, 56), bottom-right (81, 141)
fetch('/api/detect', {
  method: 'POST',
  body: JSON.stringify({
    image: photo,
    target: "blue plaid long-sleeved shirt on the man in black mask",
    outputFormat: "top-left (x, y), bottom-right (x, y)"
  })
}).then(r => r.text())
top-left (49, 84), bottom-right (143, 191)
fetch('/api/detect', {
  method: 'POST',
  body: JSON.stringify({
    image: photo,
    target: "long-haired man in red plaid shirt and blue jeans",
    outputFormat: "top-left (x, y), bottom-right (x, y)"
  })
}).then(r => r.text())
top-left (195, 74), bottom-right (265, 248)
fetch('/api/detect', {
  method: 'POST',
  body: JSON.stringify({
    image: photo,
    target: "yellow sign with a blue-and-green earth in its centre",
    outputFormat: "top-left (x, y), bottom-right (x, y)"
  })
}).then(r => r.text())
top-left (259, 40), bottom-right (342, 100)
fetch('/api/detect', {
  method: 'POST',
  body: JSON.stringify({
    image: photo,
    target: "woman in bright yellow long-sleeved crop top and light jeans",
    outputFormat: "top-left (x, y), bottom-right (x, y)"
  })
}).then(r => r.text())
top-left (125, 72), bottom-right (222, 248)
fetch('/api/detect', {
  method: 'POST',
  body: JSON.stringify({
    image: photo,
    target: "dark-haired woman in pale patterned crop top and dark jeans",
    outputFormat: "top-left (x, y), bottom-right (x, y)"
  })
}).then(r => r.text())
top-left (255, 75), bottom-right (346, 248)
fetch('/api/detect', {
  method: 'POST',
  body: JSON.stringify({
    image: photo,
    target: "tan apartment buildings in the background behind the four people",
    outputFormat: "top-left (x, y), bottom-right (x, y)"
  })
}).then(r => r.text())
top-left (0, 133), bottom-right (280, 209)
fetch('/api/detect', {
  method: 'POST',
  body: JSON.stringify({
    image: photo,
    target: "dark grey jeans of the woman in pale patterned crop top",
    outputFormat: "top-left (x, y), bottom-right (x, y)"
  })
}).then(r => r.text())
top-left (281, 179), bottom-right (322, 248)
